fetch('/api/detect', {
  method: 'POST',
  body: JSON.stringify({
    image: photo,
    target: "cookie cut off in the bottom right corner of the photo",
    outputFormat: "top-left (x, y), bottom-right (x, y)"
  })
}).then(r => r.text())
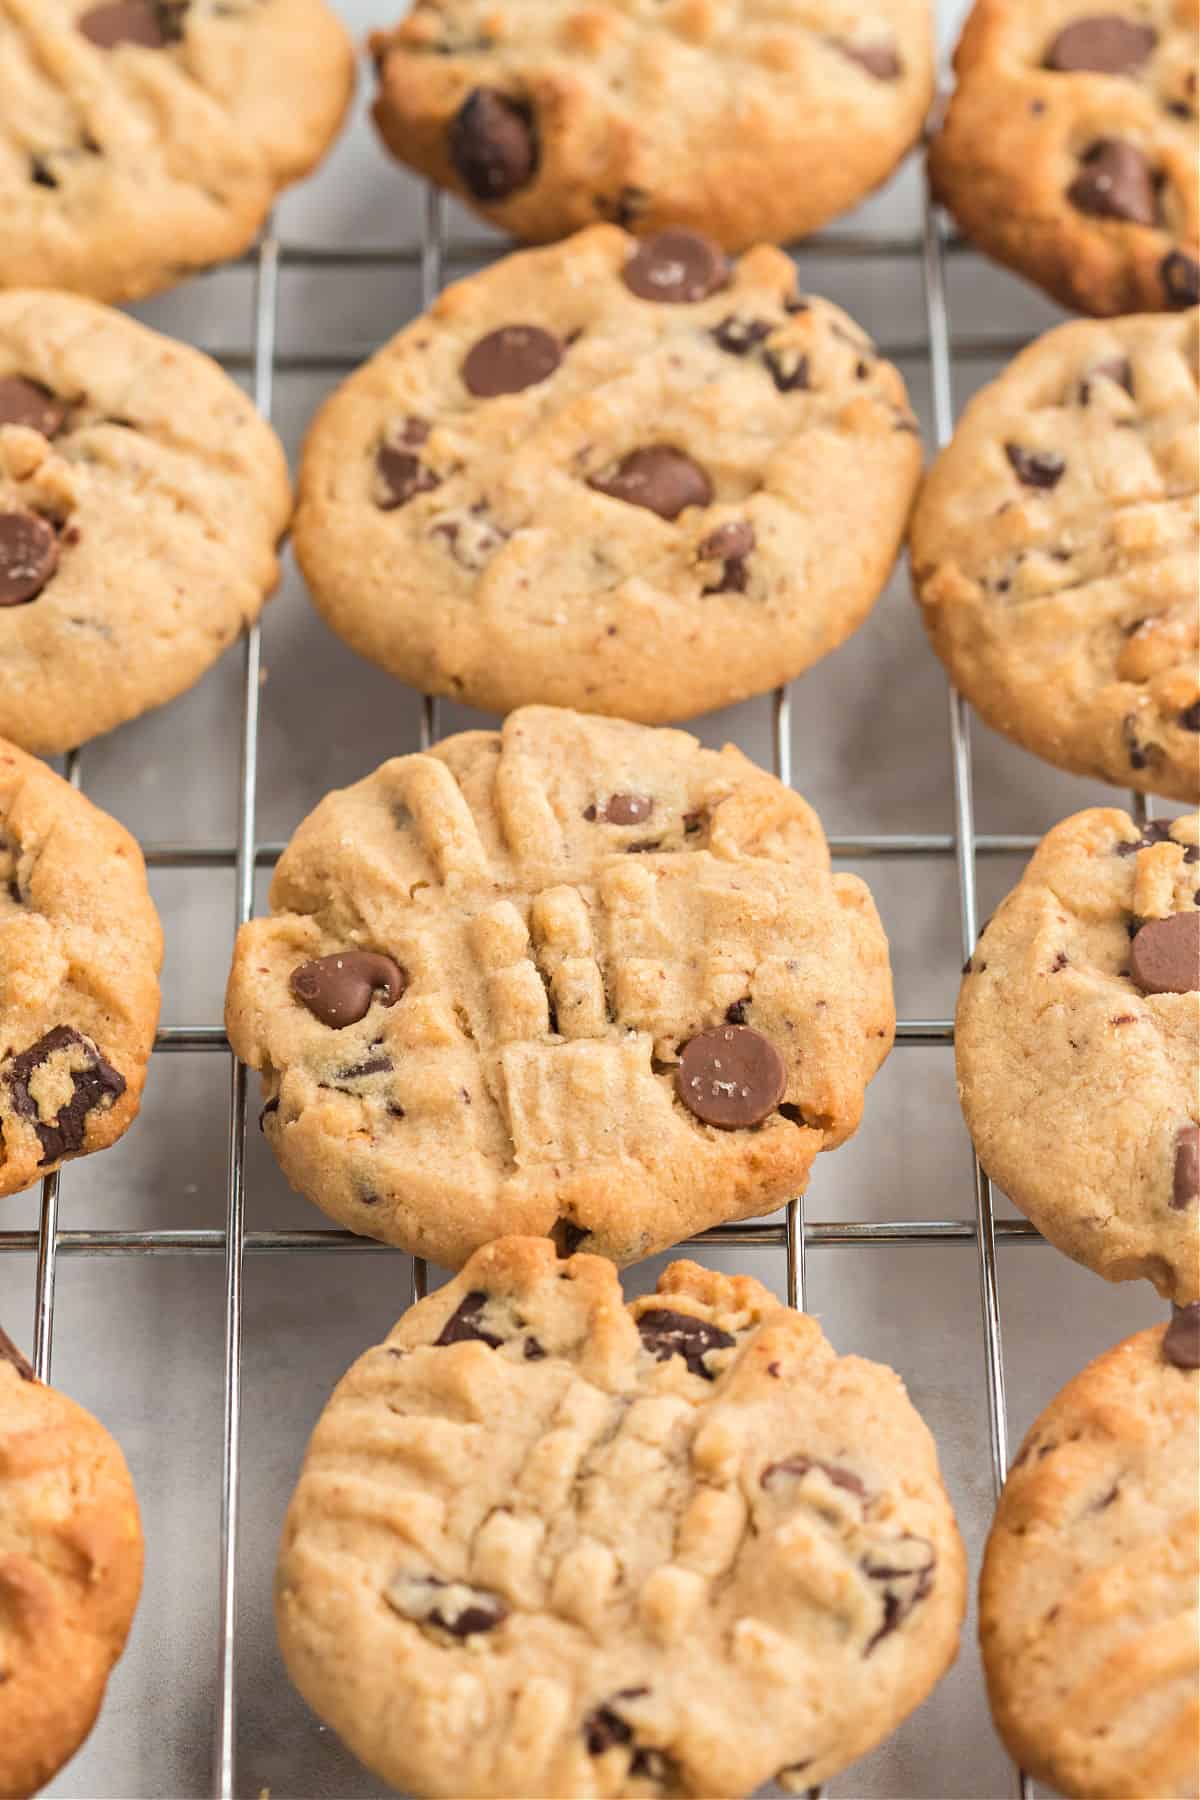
top-left (979, 1309), bottom-right (1200, 1800)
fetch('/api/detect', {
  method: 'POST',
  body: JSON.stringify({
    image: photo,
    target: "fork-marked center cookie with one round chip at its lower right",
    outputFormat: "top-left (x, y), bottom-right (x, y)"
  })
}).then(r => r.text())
top-left (225, 707), bottom-right (894, 1267)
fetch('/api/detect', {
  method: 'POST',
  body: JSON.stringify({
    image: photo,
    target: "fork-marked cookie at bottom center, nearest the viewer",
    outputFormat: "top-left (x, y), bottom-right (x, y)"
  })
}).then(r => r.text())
top-left (275, 1237), bottom-right (964, 1800)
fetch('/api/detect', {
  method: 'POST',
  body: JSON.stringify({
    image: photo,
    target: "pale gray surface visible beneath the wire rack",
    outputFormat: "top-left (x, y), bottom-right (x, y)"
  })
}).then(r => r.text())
top-left (0, 0), bottom-right (1162, 1800)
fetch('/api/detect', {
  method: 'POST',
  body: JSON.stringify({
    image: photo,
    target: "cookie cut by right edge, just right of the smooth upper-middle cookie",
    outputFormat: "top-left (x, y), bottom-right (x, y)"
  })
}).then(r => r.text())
top-left (910, 313), bottom-right (1200, 801)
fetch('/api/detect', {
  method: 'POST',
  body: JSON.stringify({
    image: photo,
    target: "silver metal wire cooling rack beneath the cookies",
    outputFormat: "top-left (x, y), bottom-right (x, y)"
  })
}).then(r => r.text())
top-left (0, 179), bottom-right (1150, 1800)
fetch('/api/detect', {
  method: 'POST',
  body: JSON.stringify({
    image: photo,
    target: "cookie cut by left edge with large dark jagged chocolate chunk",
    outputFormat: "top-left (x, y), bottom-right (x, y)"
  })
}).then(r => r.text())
top-left (0, 740), bottom-right (162, 1202)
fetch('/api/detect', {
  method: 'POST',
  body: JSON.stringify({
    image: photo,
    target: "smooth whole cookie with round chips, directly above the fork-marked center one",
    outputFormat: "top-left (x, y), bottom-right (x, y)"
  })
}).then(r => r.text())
top-left (295, 225), bottom-right (921, 724)
